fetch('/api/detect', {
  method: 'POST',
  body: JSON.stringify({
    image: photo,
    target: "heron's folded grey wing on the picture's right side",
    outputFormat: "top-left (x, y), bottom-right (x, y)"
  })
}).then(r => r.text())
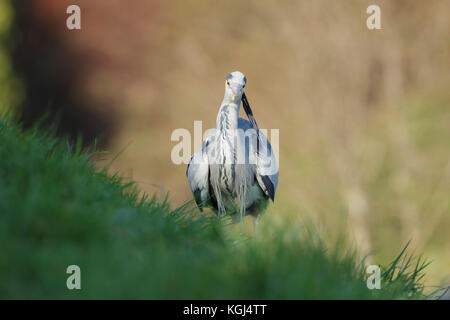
top-left (238, 118), bottom-right (278, 201)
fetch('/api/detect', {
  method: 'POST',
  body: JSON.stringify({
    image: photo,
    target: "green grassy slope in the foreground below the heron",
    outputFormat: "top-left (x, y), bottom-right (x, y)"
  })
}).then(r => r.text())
top-left (0, 119), bottom-right (438, 299)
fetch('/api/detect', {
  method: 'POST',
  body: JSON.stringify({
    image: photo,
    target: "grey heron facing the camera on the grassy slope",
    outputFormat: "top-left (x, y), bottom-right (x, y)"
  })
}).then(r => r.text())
top-left (186, 71), bottom-right (278, 234)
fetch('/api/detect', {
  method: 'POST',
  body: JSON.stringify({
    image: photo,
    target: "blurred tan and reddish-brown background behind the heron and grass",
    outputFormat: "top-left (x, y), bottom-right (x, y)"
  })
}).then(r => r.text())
top-left (0, 0), bottom-right (450, 285)
